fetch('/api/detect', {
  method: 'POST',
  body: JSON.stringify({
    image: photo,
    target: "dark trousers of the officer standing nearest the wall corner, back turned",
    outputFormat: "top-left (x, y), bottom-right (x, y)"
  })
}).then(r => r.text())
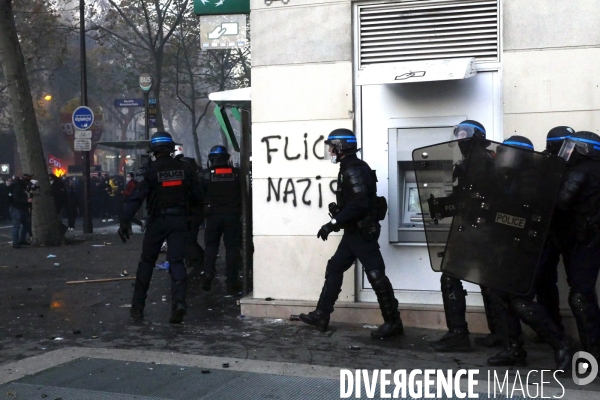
top-left (204, 214), bottom-right (242, 284)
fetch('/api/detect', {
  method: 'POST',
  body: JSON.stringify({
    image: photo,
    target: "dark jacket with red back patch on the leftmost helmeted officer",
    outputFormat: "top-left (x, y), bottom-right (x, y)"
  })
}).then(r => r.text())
top-left (122, 155), bottom-right (203, 220)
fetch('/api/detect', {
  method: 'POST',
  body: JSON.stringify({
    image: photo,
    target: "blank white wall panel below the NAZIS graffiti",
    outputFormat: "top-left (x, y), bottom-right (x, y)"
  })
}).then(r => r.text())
top-left (254, 232), bottom-right (354, 301)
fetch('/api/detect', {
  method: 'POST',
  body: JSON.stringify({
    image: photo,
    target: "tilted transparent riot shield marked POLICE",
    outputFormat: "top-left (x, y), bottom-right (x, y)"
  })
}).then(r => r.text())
top-left (441, 140), bottom-right (566, 295)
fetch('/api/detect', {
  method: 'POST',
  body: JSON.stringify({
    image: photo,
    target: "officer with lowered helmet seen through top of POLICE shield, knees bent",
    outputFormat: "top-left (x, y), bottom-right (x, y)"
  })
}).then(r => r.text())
top-left (487, 136), bottom-right (574, 370)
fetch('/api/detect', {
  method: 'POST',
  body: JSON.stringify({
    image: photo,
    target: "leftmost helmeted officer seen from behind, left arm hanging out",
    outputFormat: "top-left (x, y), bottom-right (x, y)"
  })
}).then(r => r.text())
top-left (118, 132), bottom-right (203, 324)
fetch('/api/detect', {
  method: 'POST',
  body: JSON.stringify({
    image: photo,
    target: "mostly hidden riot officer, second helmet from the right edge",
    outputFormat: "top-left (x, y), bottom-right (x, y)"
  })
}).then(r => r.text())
top-left (536, 126), bottom-right (575, 331)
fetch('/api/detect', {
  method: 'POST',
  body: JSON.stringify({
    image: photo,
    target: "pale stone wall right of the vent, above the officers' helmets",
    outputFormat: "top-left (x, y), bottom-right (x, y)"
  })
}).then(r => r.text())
top-left (502, 0), bottom-right (600, 150)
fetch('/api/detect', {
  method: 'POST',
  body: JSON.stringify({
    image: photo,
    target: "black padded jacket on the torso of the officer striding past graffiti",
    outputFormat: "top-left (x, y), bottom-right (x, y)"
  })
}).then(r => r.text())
top-left (334, 154), bottom-right (377, 229)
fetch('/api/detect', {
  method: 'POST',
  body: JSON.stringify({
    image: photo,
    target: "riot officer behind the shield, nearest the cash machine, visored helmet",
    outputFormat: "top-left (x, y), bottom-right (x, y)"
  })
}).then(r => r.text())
top-left (429, 120), bottom-right (500, 352)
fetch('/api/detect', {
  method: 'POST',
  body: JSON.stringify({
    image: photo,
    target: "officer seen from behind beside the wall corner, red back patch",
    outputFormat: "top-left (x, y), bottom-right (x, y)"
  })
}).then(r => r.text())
top-left (202, 145), bottom-right (242, 294)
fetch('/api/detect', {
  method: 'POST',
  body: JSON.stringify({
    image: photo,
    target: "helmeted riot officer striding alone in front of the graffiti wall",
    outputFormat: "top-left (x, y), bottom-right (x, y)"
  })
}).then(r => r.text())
top-left (300, 129), bottom-right (404, 339)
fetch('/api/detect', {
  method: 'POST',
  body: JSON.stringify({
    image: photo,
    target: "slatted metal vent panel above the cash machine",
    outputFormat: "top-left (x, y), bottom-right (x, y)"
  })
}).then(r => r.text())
top-left (358, 0), bottom-right (499, 68)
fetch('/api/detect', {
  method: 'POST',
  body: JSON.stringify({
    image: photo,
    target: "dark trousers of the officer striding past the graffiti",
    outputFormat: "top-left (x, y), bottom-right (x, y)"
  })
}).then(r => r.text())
top-left (317, 230), bottom-right (385, 314)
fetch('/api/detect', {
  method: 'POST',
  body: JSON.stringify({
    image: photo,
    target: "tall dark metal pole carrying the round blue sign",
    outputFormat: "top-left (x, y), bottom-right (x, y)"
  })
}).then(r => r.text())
top-left (79, 0), bottom-right (94, 233)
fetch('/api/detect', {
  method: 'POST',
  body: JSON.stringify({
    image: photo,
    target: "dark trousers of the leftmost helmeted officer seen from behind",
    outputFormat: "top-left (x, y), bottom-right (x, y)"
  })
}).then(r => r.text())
top-left (131, 215), bottom-right (188, 308)
